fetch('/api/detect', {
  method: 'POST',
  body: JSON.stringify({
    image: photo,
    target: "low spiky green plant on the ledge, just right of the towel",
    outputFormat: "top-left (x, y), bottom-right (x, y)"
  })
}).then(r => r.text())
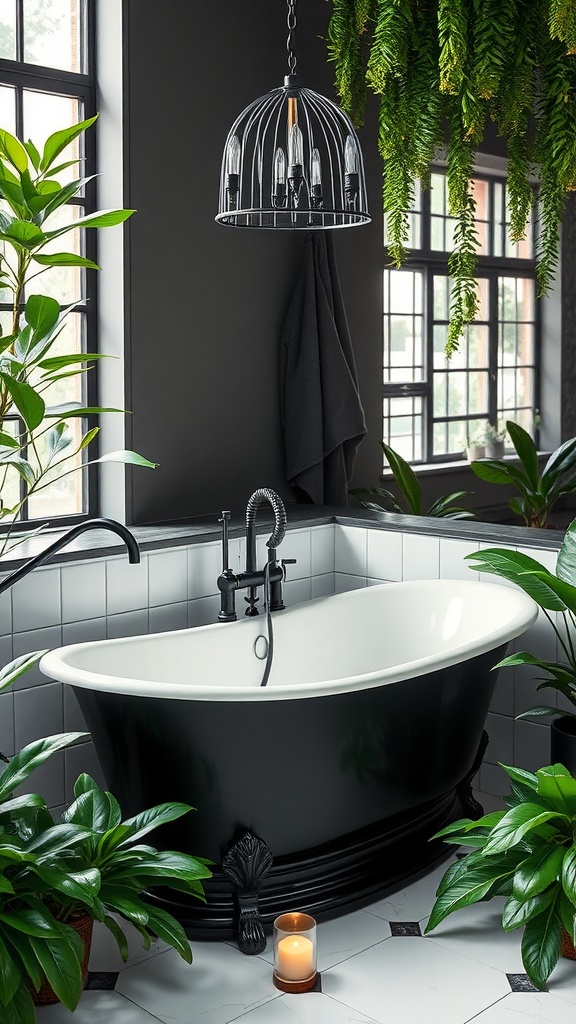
top-left (351, 441), bottom-right (475, 519)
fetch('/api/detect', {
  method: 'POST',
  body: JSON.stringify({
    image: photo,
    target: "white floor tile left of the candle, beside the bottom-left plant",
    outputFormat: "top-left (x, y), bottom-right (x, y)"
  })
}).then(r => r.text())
top-left (116, 942), bottom-right (278, 1024)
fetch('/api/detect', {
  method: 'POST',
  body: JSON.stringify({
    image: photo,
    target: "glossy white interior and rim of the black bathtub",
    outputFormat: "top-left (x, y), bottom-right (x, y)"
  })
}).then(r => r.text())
top-left (40, 580), bottom-right (537, 700)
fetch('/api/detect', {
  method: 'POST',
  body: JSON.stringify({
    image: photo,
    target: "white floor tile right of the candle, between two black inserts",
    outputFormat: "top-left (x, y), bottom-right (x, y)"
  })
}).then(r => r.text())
top-left (322, 938), bottom-right (509, 1024)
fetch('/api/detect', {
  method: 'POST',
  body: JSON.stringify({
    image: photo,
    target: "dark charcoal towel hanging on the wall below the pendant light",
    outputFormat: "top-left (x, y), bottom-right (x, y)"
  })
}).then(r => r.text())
top-left (280, 231), bottom-right (366, 506)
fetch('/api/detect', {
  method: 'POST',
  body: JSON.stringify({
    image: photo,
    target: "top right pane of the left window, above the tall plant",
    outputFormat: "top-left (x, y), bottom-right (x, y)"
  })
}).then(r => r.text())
top-left (24, 0), bottom-right (87, 73)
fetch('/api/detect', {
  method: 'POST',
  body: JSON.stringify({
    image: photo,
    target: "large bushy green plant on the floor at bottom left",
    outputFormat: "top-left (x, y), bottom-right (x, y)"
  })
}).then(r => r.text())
top-left (0, 716), bottom-right (211, 1024)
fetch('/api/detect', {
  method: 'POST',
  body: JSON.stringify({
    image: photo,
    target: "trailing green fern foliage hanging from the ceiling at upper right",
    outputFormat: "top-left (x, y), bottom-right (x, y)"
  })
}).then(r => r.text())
top-left (328, 0), bottom-right (576, 355)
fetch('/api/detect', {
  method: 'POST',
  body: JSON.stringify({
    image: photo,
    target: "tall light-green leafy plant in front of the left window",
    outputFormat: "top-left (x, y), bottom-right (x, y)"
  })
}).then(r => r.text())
top-left (0, 118), bottom-right (155, 557)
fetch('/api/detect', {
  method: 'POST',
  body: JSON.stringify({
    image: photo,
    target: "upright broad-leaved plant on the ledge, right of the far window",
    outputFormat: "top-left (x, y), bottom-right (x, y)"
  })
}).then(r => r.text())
top-left (471, 420), bottom-right (576, 527)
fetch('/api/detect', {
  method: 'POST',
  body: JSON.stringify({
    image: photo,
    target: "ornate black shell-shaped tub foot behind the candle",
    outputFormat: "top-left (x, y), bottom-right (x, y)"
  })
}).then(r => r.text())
top-left (222, 831), bottom-right (272, 955)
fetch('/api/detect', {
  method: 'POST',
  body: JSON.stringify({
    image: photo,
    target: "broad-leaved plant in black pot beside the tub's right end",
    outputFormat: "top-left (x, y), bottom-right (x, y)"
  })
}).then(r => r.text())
top-left (465, 519), bottom-right (576, 774)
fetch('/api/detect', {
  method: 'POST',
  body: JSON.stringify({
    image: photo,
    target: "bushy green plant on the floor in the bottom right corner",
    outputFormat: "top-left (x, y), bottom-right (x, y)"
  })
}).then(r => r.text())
top-left (425, 764), bottom-right (576, 989)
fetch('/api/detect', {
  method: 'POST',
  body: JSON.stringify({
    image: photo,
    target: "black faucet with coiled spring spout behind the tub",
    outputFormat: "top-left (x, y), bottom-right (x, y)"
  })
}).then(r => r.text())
top-left (217, 487), bottom-right (296, 623)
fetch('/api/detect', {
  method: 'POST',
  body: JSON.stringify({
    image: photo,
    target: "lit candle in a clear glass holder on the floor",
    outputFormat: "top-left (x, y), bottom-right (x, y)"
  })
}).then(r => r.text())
top-left (274, 912), bottom-right (317, 992)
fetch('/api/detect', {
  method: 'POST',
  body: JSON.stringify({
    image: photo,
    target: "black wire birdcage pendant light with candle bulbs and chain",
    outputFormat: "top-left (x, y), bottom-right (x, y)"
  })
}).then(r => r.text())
top-left (215, 0), bottom-right (370, 230)
